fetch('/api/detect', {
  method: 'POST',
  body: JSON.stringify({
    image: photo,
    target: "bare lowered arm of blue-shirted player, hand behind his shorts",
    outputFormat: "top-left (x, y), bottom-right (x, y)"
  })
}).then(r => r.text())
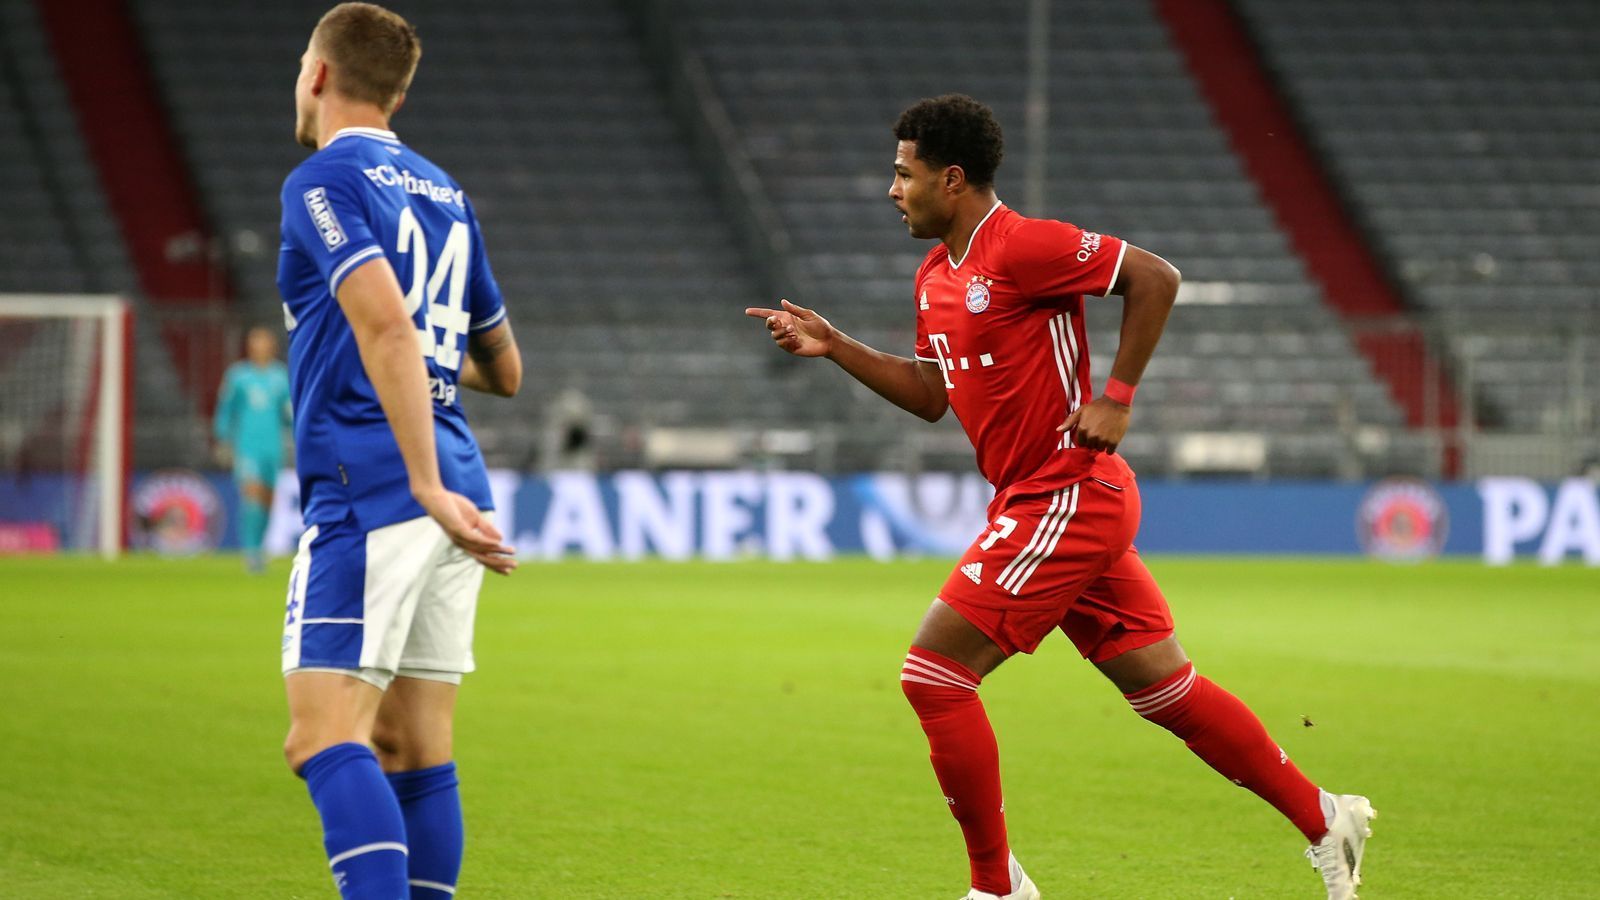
top-left (339, 256), bottom-right (517, 575)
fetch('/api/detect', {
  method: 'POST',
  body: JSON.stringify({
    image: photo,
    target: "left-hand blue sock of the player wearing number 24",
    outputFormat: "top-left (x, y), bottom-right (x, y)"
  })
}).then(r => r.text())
top-left (299, 743), bottom-right (409, 900)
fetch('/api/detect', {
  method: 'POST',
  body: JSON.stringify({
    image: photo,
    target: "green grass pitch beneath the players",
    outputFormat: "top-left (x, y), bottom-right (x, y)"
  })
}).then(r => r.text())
top-left (0, 559), bottom-right (1600, 900)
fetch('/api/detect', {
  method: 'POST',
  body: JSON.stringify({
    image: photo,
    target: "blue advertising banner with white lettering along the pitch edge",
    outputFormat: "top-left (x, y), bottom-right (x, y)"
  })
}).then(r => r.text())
top-left (0, 469), bottom-right (1600, 565)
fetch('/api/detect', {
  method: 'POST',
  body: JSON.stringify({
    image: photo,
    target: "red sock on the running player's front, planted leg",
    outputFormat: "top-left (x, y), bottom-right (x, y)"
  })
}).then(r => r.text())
top-left (901, 647), bottom-right (1004, 897)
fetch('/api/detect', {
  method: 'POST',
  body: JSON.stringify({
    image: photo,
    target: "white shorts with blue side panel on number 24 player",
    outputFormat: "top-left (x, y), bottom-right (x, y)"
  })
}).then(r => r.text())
top-left (283, 512), bottom-right (493, 689)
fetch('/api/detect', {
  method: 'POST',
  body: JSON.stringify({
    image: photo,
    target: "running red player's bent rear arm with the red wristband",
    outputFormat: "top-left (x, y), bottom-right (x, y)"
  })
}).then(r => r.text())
top-left (1058, 245), bottom-right (1182, 453)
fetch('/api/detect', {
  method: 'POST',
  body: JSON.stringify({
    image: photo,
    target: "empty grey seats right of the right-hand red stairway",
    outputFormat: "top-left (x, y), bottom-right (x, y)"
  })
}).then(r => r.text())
top-left (1238, 0), bottom-right (1600, 436)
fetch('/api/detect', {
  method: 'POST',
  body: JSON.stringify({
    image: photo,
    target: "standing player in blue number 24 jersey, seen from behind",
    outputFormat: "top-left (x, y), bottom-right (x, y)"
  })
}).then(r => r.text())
top-left (278, 3), bottom-right (522, 900)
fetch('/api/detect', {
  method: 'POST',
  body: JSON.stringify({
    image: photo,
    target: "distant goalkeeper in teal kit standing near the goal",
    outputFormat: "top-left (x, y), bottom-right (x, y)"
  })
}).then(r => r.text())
top-left (213, 325), bottom-right (290, 572)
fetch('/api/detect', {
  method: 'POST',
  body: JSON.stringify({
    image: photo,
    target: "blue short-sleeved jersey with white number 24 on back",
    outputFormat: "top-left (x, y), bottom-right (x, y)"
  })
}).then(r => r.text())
top-left (278, 128), bottom-right (506, 530)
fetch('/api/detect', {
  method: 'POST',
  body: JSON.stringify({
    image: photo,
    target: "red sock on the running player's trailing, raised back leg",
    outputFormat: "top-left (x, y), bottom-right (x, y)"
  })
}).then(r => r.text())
top-left (1132, 663), bottom-right (1328, 844)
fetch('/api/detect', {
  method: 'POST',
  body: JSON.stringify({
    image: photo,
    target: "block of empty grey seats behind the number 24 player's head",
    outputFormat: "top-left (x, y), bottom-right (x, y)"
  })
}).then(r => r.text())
top-left (134, 0), bottom-right (770, 464)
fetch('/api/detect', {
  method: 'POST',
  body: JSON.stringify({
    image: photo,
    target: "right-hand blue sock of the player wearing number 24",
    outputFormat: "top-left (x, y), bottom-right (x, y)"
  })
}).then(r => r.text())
top-left (389, 762), bottom-right (466, 900)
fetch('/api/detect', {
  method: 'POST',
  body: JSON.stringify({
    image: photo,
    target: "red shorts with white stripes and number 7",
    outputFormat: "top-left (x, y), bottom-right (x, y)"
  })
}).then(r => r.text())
top-left (939, 472), bottom-right (1173, 663)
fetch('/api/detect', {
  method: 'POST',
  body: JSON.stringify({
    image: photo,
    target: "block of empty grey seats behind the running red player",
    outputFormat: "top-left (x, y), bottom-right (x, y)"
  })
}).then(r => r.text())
top-left (682, 0), bottom-right (1408, 474)
